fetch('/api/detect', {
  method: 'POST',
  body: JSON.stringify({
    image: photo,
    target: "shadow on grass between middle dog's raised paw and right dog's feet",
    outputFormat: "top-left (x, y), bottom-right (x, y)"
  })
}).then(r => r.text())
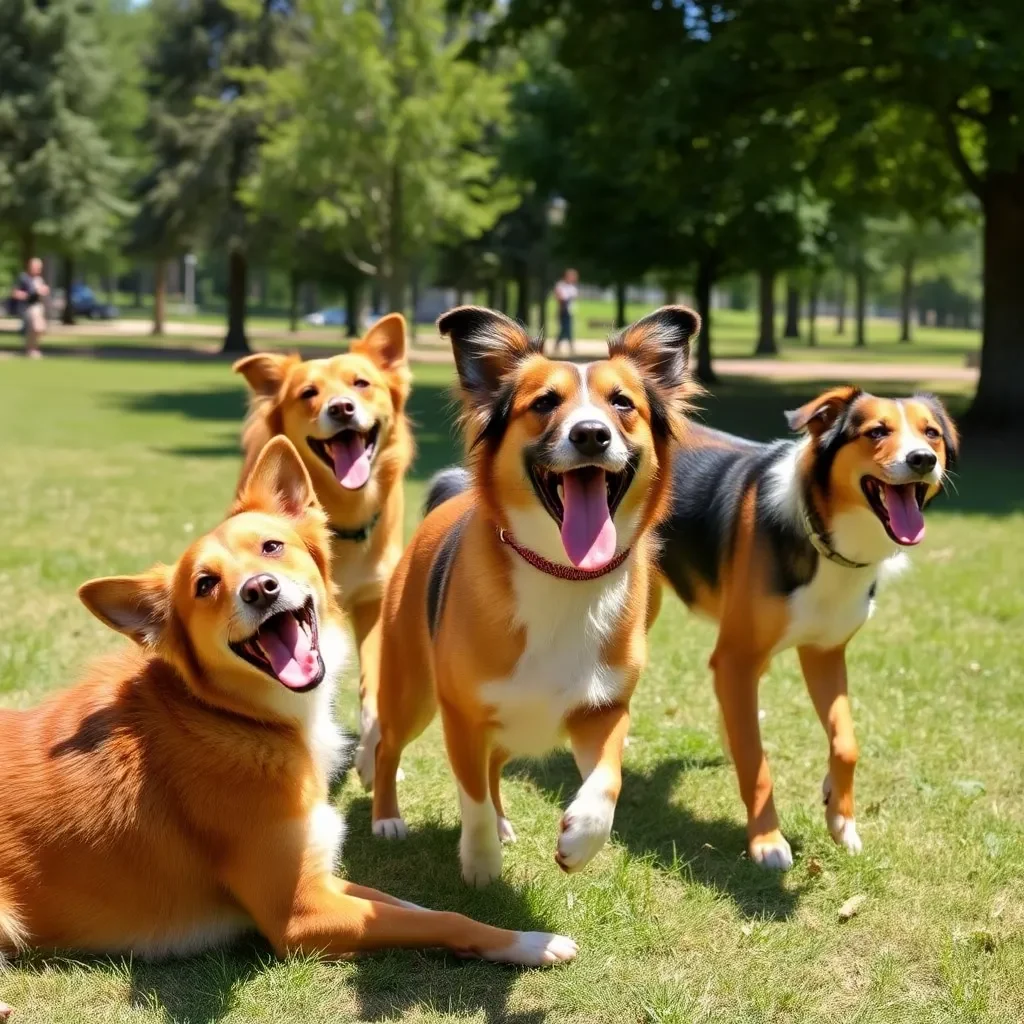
top-left (508, 751), bottom-right (800, 921)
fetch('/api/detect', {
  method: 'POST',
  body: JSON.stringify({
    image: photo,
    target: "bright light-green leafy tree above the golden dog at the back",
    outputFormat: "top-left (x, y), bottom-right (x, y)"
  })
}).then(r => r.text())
top-left (251, 0), bottom-right (516, 319)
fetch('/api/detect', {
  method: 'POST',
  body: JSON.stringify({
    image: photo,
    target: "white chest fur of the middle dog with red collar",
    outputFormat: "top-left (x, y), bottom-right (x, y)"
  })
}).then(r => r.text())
top-left (480, 561), bottom-right (630, 755)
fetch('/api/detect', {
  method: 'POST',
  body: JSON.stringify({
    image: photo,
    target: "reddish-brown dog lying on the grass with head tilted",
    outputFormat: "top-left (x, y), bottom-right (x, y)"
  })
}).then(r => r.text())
top-left (0, 437), bottom-right (575, 965)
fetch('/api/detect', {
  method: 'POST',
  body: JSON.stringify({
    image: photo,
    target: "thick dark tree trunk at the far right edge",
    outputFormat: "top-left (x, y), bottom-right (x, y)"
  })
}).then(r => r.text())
top-left (965, 156), bottom-right (1024, 434)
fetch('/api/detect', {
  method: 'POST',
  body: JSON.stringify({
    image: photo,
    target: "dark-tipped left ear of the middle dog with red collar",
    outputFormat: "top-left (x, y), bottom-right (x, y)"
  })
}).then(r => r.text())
top-left (437, 306), bottom-right (540, 412)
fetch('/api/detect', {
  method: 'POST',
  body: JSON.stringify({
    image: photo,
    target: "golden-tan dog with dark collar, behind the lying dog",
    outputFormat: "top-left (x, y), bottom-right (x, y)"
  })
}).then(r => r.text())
top-left (233, 313), bottom-right (415, 737)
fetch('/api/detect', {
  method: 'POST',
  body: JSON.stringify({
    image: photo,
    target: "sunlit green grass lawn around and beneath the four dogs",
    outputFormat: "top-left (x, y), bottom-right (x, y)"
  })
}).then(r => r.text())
top-left (0, 357), bottom-right (1024, 1024)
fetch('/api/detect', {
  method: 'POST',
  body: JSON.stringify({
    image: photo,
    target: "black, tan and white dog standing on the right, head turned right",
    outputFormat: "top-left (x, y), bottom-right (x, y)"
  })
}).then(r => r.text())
top-left (651, 387), bottom-right (957, 869)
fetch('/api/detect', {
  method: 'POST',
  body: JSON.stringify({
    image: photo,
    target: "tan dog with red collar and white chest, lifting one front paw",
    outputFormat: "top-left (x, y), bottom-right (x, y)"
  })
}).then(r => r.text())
top-left (356, 306), bottom-right (699, 885)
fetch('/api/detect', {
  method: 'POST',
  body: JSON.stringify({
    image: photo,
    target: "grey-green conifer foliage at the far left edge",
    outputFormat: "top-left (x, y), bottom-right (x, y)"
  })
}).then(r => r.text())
top-left (0, 0), bottom-right (128, 278)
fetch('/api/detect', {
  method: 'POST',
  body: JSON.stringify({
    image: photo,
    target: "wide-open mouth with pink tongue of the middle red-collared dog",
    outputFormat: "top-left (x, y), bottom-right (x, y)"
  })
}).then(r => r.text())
top-left (529, 464), bottom-right (636, 569)
